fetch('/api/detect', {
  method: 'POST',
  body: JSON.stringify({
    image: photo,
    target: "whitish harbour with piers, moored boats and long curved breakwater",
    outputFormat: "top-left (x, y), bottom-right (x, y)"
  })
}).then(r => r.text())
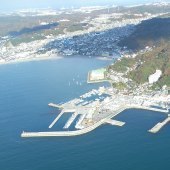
top-left (21, 87), bottom-right (170, 137)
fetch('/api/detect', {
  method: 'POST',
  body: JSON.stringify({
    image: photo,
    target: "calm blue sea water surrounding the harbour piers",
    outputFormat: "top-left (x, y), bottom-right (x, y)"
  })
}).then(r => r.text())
top-left (0, 58), bottom-right (170, 170)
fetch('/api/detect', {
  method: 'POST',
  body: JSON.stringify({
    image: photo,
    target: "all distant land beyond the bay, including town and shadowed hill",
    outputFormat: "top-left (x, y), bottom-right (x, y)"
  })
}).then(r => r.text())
top-left (0, 3), bottom-right (170, 63)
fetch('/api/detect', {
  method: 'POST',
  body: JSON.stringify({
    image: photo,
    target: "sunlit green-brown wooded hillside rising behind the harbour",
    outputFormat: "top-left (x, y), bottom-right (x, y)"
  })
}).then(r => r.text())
top-left (109, 41), bottom-right (170, 88)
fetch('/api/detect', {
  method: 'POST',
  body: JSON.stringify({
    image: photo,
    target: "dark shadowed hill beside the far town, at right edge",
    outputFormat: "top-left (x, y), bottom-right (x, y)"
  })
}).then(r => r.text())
top-left (119, 16), bottom-right (170, 50)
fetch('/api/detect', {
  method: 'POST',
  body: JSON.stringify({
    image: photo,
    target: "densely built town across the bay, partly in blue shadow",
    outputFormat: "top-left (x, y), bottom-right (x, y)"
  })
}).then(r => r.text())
top-left (0, 4), bottom-right (169, 64)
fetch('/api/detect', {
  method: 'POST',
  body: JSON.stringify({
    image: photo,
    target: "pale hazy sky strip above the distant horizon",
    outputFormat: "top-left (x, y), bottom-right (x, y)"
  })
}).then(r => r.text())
top-left (0, 0), bottom-right (170, 12)
